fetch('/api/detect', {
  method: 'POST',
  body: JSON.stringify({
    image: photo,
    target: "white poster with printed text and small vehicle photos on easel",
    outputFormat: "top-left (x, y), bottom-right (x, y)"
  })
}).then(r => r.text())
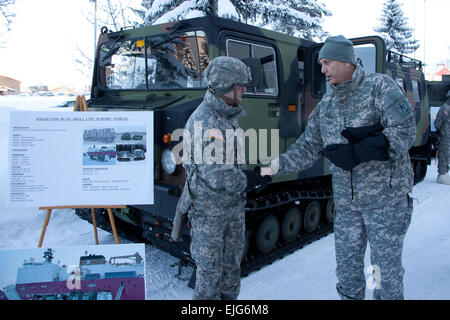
top-left (7, 111), bottom-right (154, 207)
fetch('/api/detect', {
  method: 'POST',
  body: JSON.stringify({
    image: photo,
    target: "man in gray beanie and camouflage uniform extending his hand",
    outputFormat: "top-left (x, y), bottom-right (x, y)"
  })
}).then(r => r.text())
top-left (261, 36), bottom-right (416, 299)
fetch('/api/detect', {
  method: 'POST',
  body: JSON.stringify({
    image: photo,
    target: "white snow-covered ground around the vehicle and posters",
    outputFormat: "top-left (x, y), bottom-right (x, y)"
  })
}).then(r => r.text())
top-left (0, 97), bottom-right (450, 300)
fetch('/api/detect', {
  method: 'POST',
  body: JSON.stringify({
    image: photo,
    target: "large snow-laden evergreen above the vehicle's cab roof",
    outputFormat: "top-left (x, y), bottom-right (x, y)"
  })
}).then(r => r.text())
top-left (145, 0), bottom-right (331, 39)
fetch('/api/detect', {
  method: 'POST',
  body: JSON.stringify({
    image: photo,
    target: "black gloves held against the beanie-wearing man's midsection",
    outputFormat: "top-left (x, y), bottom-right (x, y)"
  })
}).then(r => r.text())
top-left (322, 133), bottom-right (389, 170)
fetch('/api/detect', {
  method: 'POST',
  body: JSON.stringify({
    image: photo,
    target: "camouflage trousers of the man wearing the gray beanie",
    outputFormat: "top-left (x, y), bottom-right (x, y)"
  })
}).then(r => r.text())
top-left (334, 196), bottom-right (413, 300)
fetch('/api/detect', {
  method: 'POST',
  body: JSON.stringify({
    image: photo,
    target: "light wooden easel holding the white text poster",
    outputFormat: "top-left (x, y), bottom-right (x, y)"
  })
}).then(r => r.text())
top-left (38, 96), bottom-right (127, 248)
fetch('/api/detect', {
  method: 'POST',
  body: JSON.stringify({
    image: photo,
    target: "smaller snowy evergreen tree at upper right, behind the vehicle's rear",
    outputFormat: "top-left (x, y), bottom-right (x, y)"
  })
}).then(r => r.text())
top-left (374, 0), bottom-right (419, 53)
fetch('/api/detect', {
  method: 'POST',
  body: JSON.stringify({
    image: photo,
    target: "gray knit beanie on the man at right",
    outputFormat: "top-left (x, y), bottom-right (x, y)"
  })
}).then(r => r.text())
top-left (318, 35), bottom-right (356, 66)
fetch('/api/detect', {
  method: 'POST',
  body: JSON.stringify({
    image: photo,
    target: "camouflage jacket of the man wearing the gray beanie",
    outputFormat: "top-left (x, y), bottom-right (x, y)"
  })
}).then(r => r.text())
top-left (272, 65), bottom-right (416, 208)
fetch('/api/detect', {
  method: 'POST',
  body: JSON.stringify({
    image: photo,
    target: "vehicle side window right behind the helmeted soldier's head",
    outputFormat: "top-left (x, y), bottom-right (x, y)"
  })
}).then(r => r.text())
top-left (227, 40), bottom-right (278, 96)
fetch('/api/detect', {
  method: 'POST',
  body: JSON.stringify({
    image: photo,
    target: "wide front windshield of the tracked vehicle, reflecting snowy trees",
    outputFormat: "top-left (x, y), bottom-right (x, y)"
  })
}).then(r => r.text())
top-left (99, 31), bottom-right (209, 90)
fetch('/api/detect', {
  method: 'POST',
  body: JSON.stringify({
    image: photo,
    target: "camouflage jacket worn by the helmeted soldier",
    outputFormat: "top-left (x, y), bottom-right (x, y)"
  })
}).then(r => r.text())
top-left (180, 91), bottom-right (247, 215)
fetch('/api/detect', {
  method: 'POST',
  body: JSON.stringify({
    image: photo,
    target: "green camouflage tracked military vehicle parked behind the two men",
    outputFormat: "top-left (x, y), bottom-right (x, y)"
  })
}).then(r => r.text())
top-left (78, 16), bottom-right (430, 275)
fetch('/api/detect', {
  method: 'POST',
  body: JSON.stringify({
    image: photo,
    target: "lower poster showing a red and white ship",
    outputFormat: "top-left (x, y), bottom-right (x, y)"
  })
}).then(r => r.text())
top-left (0, 243), bottom-right (146, 301)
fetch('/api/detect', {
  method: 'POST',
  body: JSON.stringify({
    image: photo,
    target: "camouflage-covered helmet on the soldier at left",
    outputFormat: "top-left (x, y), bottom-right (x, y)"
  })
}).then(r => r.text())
top-left (205, 56), bottom-right (251, 94)
